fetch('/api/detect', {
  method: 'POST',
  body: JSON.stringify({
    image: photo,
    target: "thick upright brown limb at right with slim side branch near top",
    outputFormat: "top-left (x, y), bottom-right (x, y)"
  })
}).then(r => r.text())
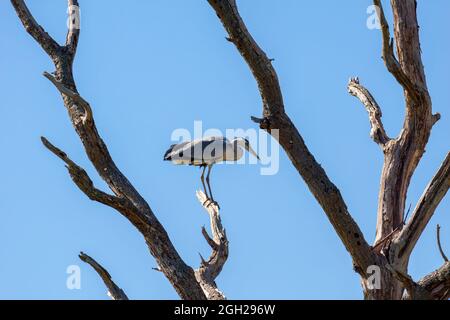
top-left (374, 0), bottom-right (437, 255)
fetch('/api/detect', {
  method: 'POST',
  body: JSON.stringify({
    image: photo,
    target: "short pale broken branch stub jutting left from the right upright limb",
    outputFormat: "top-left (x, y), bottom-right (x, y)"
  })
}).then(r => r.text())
top-left (348, 78), bottom-right (391, 149)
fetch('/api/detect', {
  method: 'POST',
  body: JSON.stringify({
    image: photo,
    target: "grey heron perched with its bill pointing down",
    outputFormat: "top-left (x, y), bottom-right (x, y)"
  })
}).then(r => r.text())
top-left (164, 137), bottom-right (259, 204)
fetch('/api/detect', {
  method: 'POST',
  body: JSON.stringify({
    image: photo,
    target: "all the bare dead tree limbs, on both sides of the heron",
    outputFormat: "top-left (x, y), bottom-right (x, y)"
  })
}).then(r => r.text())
top-left (11, 0), bottom-right (450, 299)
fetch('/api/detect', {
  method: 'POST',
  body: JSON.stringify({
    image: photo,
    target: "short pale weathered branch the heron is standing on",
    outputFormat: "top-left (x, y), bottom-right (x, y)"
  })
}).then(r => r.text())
top-left (195, 191), bottom-right (228, 300)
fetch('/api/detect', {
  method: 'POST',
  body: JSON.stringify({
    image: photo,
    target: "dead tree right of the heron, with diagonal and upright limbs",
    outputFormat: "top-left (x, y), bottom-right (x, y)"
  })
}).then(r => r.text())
top-left (208, 0), bottom-right (450, 299)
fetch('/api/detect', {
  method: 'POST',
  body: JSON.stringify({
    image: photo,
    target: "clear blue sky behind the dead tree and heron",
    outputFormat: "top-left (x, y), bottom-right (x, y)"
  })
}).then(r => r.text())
top-left (0, 0), bottom-right (450, 299)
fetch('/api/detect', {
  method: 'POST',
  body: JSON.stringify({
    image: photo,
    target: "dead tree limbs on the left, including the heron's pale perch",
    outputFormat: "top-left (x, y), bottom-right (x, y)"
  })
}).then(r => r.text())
top-left (11, 0), bottom-right (228, 300)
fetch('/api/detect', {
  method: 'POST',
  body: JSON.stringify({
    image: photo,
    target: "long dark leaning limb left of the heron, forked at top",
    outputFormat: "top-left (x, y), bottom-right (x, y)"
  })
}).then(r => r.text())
top-left (11, 0), bottom-right (206, 300)
